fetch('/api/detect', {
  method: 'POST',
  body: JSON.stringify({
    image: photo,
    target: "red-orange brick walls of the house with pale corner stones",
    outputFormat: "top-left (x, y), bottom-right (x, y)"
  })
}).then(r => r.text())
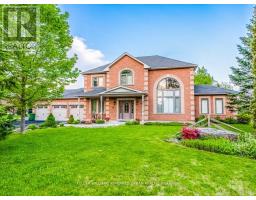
top-left (39, 55), bottom-right (234, 122)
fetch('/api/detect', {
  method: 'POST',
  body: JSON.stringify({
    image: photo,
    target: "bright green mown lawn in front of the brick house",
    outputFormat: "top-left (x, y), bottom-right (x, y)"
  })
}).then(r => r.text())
top-left (0, 126), bottom-right (256, 195)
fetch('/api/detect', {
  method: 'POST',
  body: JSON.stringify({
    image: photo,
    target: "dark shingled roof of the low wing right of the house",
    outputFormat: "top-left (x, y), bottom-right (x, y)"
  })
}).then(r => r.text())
top-left (195, 85), bottom-right (238, 95)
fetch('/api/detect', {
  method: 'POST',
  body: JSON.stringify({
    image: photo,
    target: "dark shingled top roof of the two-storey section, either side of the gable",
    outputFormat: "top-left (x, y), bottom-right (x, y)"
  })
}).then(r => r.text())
top-left (84, 55), bottom-right (197, 74)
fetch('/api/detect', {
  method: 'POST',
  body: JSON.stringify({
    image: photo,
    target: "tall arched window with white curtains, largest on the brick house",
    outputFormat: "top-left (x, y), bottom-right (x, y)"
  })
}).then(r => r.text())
top-left (156, 78), bottom-right (181, 114)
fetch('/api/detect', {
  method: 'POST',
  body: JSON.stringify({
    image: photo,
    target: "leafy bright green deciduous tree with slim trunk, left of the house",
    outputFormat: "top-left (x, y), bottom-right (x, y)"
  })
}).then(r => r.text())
top-left (1, 5), bottom-right (79, 132)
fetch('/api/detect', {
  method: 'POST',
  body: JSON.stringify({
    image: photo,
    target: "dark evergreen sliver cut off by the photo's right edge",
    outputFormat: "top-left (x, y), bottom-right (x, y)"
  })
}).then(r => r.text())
top-left (251, 6), bottom-right (256, 129)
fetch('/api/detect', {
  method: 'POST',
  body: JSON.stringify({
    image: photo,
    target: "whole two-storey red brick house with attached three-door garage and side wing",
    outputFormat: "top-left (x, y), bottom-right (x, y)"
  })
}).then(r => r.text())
top-left (35, 53), bottom-right (238, 123)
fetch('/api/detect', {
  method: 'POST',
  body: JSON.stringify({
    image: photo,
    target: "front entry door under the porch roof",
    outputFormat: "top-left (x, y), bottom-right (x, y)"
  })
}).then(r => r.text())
top-left (119, 100), bottom-right (134, 120)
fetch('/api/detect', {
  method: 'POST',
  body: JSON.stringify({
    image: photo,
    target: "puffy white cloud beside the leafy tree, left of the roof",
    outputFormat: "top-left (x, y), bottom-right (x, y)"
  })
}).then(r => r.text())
top-left (66, 36), bottom-right (108, 89)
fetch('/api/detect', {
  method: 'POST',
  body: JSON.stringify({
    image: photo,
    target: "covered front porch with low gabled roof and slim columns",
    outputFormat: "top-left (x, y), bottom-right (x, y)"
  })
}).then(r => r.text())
top-left (85, 87), bottom-right (148, 122)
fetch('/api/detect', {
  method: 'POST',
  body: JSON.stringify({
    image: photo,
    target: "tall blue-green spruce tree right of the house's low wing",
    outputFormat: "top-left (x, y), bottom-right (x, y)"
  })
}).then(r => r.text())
top-left (229, 7), bottom-right (256, 113)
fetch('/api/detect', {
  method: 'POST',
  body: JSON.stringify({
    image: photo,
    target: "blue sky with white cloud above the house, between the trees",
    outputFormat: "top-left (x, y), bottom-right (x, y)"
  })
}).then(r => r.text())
top-left (60, 5), bottom-right (252, 88)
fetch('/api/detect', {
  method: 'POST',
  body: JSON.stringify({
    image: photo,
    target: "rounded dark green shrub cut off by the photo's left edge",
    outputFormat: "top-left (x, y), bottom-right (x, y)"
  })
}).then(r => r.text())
top-left (0, 106), bottom-right (15, 140)
